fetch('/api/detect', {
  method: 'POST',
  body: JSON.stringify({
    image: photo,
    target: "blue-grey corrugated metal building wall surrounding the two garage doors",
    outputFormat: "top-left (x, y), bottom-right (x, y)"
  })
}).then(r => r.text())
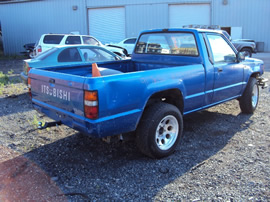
top-left (0, 0), bottom-right (270, 54)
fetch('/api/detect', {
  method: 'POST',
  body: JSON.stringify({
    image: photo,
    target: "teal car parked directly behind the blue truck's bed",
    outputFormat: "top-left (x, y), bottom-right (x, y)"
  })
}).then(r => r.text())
top-left (21, 45), bottom-right (121, 85)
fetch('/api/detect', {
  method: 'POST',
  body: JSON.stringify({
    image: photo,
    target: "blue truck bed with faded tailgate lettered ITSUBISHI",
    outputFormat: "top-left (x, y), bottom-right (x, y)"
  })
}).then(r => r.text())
top-left (29, 56), bottom-right (205, 137)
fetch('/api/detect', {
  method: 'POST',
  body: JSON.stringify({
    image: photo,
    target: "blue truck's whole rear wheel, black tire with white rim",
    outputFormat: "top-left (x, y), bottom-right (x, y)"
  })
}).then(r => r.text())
top-left (136, 102), bottom-right (183, 158)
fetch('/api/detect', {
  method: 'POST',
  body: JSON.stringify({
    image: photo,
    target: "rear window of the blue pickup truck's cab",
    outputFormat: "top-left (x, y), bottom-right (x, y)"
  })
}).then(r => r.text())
top-left (135, 32), bottom-right (199, 56)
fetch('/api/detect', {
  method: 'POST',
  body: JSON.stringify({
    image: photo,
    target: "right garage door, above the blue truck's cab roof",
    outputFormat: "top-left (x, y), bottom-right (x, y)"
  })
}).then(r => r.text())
top-left (169, 4), bottom-right (211, 28)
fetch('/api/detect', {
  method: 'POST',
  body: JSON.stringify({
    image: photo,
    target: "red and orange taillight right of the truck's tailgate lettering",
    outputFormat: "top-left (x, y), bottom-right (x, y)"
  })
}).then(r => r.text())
top-left (84, 91), bottom-right (98, 119)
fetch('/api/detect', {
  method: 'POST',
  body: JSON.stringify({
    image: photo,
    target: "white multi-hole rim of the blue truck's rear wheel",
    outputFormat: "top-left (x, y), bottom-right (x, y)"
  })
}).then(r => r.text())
top-left (156, 115), bottom-right (179, 150)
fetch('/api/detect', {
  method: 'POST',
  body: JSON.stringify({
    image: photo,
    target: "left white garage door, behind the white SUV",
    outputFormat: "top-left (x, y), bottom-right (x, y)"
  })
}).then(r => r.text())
top-left (88, 7), bottom-right (126, 43)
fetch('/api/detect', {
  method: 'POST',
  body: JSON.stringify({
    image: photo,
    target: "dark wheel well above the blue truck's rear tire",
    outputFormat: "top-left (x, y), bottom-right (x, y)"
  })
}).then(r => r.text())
top-left (146, 89), bottom-right (184, 113)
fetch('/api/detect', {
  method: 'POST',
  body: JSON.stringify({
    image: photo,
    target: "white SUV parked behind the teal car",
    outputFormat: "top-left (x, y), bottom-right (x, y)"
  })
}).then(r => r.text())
top-left (33, 34), bottom-right (127, 57)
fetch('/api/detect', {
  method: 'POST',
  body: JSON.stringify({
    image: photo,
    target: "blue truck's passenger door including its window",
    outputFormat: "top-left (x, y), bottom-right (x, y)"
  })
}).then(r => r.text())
top-left (207, 33), bottom-right (244, 103)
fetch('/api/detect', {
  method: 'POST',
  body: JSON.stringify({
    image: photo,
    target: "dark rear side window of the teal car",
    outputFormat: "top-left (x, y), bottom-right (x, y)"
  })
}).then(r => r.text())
top-left (58, 48), bottom-right (82, 62)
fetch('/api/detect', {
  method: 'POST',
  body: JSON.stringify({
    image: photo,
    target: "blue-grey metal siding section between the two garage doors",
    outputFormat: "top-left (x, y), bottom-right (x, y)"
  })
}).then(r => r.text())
top-left (126, 4), bottom-right (168, 37)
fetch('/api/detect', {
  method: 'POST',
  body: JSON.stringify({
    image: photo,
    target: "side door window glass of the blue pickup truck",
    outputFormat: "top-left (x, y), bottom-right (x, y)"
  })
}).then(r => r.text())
top-left (207, 34), bottom-right (236, 63)
